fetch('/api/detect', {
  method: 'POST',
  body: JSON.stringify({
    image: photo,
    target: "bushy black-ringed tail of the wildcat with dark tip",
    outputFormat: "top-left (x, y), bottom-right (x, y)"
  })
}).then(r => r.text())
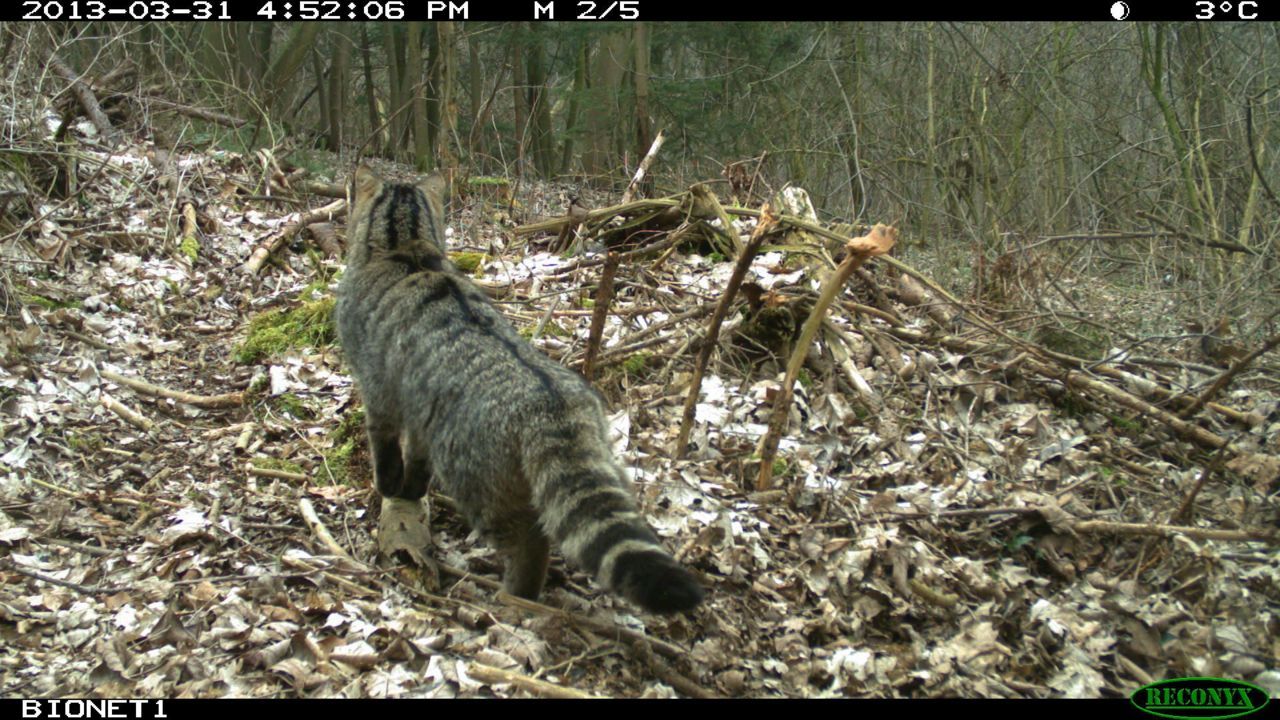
top-left (534, 460), bottom-right (703, 612)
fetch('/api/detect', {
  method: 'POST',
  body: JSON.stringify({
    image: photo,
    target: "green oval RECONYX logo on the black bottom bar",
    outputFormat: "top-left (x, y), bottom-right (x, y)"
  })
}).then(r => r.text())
top-left (1129, 678), bottom-right (1270, 720)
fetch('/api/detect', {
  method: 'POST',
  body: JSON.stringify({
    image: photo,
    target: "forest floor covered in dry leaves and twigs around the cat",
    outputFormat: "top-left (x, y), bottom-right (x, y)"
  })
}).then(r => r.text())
top-left (0, 120), bottom-right (1280, 697)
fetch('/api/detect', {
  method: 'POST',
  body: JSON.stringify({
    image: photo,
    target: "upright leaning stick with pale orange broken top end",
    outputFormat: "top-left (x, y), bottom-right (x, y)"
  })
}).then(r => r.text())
top-left (755, 224), bottom-right (897, 491)
